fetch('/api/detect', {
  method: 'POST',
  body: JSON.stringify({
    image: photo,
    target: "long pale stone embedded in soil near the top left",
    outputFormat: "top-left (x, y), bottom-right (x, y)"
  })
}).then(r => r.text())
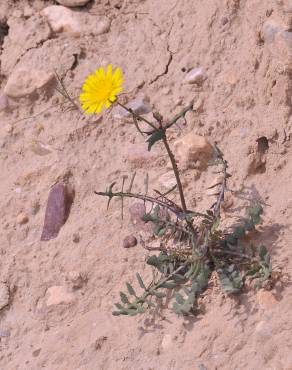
top-left (42, 5), bottom-right (111, 37)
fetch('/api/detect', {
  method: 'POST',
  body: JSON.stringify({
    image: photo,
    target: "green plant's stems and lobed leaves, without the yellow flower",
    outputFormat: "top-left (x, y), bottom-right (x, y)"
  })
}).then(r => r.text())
top-left (95, 99), bottom-right (272, 316)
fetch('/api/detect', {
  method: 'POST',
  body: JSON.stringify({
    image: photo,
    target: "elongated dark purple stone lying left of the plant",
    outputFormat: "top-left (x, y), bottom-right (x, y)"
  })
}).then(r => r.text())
top-left (41, 184), bottom-right (73, 241)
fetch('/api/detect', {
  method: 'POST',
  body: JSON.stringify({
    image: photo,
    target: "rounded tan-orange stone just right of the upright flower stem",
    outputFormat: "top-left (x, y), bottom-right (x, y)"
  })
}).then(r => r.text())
top-left (174, 132), bottom-right (213, 170)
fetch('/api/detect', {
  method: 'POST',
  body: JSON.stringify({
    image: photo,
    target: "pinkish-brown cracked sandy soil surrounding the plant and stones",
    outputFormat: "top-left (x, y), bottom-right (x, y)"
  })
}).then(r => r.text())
top-left (0, 0), bottom-right (292, 370)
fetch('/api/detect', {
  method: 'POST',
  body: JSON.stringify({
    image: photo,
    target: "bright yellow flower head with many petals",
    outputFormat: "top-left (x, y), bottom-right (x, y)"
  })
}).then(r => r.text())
top-left (80, 64), bottom-right (123, 114)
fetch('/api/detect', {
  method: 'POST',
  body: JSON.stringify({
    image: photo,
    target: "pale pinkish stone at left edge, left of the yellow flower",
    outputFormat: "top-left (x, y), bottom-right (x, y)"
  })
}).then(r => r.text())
top-left (4, 67), bottom-right (54, 99)
